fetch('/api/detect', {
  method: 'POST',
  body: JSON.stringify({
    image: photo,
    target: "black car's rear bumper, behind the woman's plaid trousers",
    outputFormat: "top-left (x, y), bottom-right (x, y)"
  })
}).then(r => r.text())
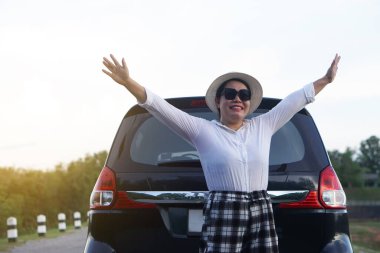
top-left (84, 208), bottom-right (352, 253)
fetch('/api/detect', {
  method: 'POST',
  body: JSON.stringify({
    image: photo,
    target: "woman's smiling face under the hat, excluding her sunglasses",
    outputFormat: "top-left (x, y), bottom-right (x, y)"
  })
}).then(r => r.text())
top-left (216, 80), bottom-right (250, 130)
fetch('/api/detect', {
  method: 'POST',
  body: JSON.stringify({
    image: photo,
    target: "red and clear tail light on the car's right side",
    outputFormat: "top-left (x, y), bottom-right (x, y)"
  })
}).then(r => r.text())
top-left (279, 166), bottom-right (346, 209)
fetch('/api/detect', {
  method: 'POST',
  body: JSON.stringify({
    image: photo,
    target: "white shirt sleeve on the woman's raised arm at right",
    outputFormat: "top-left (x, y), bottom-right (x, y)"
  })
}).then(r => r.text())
top-left (262, 83), bottom-right (315, 133)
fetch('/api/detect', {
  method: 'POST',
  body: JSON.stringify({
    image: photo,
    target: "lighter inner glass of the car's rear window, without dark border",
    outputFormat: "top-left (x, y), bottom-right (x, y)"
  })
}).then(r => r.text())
top-left (131, 112), bottom-right (305, 165)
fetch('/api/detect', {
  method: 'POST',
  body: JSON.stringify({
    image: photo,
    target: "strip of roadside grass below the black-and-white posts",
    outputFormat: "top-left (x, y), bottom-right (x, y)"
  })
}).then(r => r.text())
top-left (0, 223), bottom-right (87, 253)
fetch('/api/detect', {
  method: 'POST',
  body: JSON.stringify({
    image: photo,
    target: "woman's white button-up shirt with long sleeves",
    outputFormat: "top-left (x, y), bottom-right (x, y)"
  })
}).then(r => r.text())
top-left (140, 83), bottom-right (315, 192)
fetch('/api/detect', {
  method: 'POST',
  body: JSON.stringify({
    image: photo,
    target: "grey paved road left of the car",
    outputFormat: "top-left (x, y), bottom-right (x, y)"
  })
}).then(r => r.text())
top-left (2, 227), bottom-right (87, 253)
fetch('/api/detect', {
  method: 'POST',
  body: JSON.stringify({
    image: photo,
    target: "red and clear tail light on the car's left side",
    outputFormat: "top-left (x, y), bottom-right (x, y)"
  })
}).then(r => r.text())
top-left (90, 167), bottom-right (155, 209)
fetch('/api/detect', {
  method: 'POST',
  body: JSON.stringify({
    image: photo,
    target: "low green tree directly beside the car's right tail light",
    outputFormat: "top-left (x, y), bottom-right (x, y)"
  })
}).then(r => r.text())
top-left (328, 148), bottom-right (364, 187)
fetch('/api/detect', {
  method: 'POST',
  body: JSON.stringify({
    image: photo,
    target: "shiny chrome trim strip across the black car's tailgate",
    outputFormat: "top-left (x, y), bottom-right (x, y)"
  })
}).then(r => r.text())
top-left (127, 190), bottom-right (309, 204)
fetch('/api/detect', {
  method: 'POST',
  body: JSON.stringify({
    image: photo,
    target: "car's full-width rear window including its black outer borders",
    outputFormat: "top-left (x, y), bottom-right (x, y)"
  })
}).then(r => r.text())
top-left (105, 106), bottom-right (328, 171)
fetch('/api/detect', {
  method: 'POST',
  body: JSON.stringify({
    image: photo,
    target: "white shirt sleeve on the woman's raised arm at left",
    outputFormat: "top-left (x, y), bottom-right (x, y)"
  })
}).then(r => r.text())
top-left (139, 89), bottom-right (205, 144)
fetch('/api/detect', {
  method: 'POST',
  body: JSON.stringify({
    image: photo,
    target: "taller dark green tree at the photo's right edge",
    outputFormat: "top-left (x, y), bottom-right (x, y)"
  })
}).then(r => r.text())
top-left (358, 136), bottom-right (380, 173)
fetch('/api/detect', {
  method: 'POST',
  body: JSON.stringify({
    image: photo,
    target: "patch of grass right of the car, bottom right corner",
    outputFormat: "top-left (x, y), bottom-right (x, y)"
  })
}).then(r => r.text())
top-left (350, 220), bottom-right (380, 253)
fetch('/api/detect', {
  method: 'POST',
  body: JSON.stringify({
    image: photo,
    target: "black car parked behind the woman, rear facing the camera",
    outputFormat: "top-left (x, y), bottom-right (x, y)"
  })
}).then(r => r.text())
top-left (84, 97), bottom-right (352, 253)
